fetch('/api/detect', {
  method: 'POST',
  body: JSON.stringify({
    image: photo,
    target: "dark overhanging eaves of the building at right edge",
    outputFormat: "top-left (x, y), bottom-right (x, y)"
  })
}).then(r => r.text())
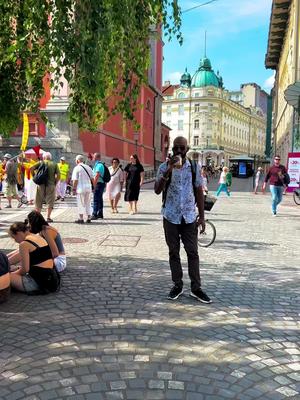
top-left (265, 0), bottom-right (290, 69)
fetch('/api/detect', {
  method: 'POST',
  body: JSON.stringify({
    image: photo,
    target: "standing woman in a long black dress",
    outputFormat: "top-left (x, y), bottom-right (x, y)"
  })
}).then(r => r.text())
top-left (124, 154), bottom-right (145, 214)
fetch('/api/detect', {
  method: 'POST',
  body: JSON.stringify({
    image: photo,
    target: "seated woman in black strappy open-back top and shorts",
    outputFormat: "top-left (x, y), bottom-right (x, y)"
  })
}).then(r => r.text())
top-left (8, 222), bottom-right (60, 294)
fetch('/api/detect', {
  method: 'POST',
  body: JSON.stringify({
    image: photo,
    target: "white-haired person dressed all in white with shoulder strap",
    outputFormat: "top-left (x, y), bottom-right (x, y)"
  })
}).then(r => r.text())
top-left (72, 154), bottom-right (93, 224)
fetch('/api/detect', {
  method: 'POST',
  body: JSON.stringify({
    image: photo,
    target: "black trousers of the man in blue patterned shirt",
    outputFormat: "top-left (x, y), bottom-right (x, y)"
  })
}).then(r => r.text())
top-left (164, 218), bottom-right (201, 291)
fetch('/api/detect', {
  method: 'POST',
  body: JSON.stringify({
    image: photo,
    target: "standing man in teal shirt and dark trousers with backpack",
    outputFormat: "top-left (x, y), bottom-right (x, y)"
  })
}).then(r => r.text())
top-left (92, 153), bottom-right (105, 220)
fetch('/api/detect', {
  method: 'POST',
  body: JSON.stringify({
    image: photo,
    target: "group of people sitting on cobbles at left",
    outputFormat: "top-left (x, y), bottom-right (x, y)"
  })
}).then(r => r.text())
top-left (0, 211), bottom-right (67, 302)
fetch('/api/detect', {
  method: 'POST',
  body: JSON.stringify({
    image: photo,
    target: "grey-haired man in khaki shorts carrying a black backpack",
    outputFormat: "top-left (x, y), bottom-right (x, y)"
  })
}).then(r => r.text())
top-left (30, 152), bottom-right (60, 222)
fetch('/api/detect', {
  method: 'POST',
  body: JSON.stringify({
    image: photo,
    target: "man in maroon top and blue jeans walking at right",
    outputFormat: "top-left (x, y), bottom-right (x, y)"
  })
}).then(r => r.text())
top-left (262, 155), bottom-right (287, 217)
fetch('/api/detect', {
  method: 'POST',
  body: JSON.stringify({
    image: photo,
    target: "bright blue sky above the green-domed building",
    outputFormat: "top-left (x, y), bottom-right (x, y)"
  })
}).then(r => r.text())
top-left (163, 0), bottom-right (273, 91)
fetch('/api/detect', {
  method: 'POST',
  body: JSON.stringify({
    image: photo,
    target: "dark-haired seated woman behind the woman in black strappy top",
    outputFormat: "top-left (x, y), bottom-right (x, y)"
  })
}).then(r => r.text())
top-left (27, 211), bottom-right (67, 272)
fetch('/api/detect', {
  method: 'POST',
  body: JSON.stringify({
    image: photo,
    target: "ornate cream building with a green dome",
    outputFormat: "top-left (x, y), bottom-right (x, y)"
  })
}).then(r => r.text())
top-left (162, 58), bottom-right (266, 165)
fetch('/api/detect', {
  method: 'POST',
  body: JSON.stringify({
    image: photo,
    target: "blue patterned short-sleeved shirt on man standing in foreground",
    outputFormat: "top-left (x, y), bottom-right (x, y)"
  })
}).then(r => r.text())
top-left (156, 160), bottom-right (202, 225)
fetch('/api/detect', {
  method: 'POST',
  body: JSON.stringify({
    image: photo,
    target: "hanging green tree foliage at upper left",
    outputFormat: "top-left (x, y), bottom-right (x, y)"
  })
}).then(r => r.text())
top-left (0, 0), bottom-right (182, 134)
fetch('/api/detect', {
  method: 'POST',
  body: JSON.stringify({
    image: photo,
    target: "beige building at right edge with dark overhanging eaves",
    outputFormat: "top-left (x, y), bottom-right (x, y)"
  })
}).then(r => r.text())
top-left (265, 0), bottom-right (300, 163)
